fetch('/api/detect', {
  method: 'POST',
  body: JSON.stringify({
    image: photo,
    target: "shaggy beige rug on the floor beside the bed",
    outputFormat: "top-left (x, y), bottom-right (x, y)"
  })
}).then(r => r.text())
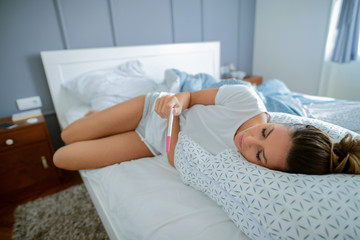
top-left (13, 184), bottom-right (109, 240)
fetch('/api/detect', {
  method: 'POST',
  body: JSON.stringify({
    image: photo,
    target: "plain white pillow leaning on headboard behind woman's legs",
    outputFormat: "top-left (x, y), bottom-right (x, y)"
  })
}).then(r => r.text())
top-left (62, 60), bottom-right (156, 110)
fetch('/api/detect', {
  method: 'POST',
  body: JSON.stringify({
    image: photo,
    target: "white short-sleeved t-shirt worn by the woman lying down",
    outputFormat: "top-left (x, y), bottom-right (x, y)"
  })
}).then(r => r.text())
top-left (180, 85), bottom-right (266, 154)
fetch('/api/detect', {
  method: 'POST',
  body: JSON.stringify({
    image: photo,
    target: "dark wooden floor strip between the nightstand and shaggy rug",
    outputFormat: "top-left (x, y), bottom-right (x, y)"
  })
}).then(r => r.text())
top-left (0, 170), bottom-right (82, 240)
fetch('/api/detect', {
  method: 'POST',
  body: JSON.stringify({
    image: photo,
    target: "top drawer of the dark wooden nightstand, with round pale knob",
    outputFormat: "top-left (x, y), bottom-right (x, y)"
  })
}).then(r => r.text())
top-left (0, 125), bottom-right (46, 152)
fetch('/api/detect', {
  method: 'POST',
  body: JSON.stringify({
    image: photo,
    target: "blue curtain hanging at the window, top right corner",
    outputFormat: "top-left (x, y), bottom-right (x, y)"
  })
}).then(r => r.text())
top-left (331, 0), bottom-right (360, 63)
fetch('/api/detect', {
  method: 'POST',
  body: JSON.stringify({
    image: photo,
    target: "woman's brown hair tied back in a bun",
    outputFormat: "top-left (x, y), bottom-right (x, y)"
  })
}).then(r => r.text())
top-left (287, 124), bottom-right (360, 174)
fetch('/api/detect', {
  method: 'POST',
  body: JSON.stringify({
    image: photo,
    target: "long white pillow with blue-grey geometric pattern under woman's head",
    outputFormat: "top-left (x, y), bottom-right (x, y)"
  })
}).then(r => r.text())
top-left (175, 113), bottom-right (360, 239)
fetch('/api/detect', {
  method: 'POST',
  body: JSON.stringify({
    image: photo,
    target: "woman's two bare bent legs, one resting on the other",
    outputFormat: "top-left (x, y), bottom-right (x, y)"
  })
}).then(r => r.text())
top-left (53, 96), bottom-right (153, 170)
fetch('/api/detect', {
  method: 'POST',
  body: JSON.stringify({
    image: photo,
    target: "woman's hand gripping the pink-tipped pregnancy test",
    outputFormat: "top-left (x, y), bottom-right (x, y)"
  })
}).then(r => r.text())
top-left (155, 95), bottom-right (183, 118)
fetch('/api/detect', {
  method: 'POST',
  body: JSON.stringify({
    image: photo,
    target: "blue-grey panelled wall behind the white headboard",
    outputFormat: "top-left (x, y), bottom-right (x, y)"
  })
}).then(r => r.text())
top-left (0, 0), bottom-right (255, 148)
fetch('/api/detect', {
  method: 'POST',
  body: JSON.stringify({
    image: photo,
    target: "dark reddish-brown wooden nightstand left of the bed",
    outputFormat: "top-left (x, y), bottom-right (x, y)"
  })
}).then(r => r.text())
top-left (0, 115), bottom-right (60, 204)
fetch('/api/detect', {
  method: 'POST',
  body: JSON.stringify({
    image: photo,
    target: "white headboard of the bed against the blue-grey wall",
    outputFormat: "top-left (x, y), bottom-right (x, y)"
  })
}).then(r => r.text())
top-left (41, 42), bottom-right (220, 128)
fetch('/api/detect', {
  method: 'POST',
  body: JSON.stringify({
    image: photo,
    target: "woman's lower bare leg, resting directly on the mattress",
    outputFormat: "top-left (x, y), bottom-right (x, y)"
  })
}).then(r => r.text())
top-left (53, 131), bottom-right (154, 170)
